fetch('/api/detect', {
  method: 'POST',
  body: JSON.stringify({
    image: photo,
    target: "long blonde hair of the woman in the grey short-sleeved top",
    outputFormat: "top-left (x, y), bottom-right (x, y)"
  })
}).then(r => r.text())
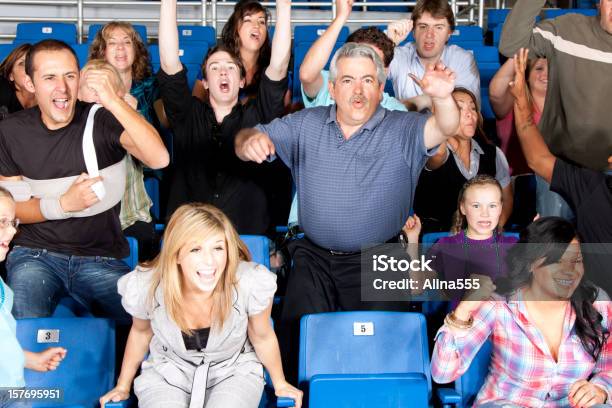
top-left (144, 203), bottom-right (251, 334)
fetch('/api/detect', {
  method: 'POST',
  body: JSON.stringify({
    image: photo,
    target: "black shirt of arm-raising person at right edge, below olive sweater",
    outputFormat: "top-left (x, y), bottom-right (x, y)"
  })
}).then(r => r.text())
top-left (550, 159), bottom-right (612, 295)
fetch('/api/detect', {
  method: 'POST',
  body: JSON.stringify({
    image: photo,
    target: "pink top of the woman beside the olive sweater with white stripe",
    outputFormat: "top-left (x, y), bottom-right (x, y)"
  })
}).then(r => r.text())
top-left (495, 105), bottom-right (542, 176)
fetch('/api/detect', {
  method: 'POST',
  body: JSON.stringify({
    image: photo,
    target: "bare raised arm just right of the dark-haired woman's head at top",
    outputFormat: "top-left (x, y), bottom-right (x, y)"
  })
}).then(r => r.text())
top-left (266, 0), bottom-right (291, 81)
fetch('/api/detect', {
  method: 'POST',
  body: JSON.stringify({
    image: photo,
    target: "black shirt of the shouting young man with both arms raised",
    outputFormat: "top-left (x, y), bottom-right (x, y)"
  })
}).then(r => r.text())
top-left (157, 67), bottom-right (291, 234)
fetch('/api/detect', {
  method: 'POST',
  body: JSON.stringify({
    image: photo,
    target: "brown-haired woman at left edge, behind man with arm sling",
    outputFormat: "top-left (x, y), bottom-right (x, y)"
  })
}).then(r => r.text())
top-left (0, 44), bottom-right (36, 120)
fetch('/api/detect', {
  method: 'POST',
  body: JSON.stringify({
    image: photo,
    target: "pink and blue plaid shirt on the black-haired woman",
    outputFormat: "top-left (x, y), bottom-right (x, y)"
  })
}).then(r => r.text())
top-left (431, 291), bottom-right (612, 408)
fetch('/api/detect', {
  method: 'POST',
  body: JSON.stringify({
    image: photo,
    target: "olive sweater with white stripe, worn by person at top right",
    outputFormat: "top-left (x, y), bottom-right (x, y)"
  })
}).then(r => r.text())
top-left (499, 0), bottom-right (612, 170)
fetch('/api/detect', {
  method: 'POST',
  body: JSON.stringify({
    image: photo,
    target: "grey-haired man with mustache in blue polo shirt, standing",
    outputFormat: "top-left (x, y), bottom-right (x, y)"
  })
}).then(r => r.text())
top-left (235, 43), bottom-right (459, 380)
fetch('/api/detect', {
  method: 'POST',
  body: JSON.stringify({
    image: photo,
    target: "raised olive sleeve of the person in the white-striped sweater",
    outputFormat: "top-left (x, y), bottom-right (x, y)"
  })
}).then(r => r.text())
top-left (499, 0), bottom-right (555, 58)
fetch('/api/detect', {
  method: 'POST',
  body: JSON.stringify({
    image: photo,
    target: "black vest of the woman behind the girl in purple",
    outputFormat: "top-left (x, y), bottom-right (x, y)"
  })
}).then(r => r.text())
top-left (414, 143), bottom-right (497, 233)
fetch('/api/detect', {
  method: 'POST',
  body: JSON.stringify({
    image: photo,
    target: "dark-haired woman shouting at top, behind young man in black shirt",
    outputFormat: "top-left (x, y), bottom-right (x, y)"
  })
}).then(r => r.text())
top-left (193, 0), bottom-right (291, 105)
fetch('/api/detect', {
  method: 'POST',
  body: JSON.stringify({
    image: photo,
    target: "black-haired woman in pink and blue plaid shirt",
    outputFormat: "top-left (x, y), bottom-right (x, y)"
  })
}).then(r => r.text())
top-left (431, 217), bottom-right (612, 408)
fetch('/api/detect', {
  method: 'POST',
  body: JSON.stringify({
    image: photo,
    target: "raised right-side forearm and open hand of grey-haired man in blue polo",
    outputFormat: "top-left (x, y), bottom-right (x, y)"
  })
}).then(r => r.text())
top-left (420, 63), bottom-right (459, 149)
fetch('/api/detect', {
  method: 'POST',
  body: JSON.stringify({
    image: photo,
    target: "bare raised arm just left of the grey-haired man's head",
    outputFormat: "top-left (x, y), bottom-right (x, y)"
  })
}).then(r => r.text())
top-left (300, 0), bottom-right (353, 98)
